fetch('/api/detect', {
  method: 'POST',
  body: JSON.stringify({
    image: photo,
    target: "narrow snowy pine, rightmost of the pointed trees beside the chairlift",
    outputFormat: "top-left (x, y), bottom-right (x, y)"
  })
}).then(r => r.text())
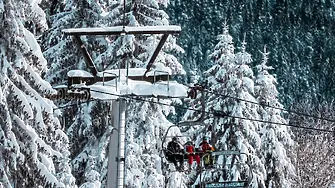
top-left (255, 47), bottom-right (295, 188)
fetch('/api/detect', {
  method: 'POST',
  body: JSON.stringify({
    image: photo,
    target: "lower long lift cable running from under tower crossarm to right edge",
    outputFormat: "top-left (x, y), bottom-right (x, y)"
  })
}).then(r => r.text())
top-left (83, 89), bottom-right (335, 134)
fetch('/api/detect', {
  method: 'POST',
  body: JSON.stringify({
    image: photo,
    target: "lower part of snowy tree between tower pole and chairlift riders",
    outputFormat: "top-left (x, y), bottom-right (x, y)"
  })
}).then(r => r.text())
top-left (126, 101), bottom-right (177, 188)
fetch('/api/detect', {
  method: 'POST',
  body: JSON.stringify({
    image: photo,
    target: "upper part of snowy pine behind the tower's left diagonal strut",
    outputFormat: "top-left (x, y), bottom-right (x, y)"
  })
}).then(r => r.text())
top-left (42, 0), bottom-right (107, 84)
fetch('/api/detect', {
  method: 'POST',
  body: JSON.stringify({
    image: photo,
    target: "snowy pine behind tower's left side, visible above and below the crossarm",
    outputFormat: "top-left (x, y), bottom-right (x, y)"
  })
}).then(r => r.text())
top-left (43, 0), bottom-right (112, 187)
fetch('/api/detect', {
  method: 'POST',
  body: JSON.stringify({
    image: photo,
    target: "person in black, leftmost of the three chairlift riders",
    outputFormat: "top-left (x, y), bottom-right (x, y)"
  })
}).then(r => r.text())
top-left (166, 137), bottom-right (184, 170)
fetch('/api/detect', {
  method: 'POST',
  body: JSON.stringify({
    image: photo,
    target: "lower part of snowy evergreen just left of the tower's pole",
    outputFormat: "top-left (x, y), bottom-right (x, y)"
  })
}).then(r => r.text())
top-left (67, 101), bottom-right (113, 187)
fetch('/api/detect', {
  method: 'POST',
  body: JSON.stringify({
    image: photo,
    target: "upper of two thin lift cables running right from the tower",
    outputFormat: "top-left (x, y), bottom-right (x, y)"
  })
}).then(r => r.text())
top-left (205, 89), bottom-right (335, 123)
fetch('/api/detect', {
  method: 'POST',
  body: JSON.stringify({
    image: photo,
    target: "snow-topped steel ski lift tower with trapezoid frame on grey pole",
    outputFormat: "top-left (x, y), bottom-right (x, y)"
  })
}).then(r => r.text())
top-left (59, 26), bottom-right (187, 188)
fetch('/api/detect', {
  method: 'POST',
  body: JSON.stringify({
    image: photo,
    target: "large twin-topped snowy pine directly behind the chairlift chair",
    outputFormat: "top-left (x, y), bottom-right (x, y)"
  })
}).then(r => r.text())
top-left (186, 24), bottom-right (265, 187)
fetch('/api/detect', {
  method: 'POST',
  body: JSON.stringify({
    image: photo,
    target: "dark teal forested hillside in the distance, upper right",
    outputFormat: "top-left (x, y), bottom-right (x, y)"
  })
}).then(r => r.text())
top-left (166, 0), bottom-right (335, 108)
